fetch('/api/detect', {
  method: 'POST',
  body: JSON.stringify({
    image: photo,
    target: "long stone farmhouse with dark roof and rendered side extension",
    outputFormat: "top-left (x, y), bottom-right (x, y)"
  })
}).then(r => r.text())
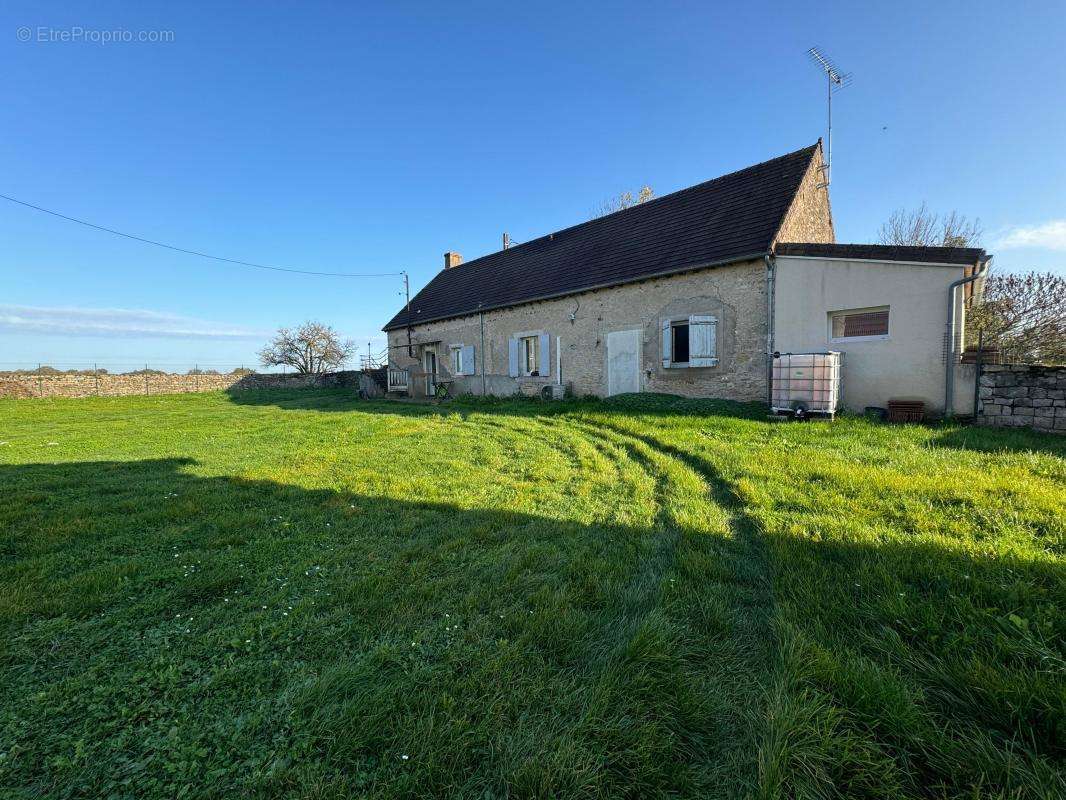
top-left (384, 141), bottom-right (989, 413)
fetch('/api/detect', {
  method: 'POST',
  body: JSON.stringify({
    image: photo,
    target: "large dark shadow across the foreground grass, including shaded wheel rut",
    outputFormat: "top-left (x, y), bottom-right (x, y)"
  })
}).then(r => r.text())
top-left (0, 454), bottom-right (1066, 797)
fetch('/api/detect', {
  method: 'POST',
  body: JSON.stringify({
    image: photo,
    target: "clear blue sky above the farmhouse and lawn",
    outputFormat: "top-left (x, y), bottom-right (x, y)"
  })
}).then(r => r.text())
top-left (0, 2), bottom-right (1066, 369)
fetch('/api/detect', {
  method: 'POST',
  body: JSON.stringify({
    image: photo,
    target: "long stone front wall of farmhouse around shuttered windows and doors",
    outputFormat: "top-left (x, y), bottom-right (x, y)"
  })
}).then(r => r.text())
top-left (389, 259), bottom-right (766, 400)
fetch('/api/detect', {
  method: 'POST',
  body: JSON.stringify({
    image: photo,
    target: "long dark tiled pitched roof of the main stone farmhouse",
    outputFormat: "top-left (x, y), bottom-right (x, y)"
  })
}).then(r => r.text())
top-left (384, 144), bottom-right (819, 331)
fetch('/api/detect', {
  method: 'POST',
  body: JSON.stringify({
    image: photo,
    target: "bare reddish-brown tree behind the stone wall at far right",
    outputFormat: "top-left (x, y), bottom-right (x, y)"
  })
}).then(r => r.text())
top-left (966, 271), bottom-right (1066, 364)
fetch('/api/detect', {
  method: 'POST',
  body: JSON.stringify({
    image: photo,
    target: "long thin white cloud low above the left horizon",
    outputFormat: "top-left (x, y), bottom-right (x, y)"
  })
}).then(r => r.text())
top-left (0, 305), bottom-right (267, 339)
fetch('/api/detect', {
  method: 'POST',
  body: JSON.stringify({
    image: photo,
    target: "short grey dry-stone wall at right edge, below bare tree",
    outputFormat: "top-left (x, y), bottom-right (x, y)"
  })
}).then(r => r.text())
top-left (978, 365), bottom-right (1066, 433)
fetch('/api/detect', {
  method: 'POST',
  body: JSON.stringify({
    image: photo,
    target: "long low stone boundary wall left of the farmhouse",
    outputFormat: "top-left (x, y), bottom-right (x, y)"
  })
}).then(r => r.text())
top-left (0, 370), bottom-right (384, 398)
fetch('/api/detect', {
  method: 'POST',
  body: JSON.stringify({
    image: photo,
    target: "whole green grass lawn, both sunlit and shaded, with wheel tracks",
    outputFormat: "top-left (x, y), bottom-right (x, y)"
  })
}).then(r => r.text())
top-left (0, 391), bottom-right (1066, 799)
